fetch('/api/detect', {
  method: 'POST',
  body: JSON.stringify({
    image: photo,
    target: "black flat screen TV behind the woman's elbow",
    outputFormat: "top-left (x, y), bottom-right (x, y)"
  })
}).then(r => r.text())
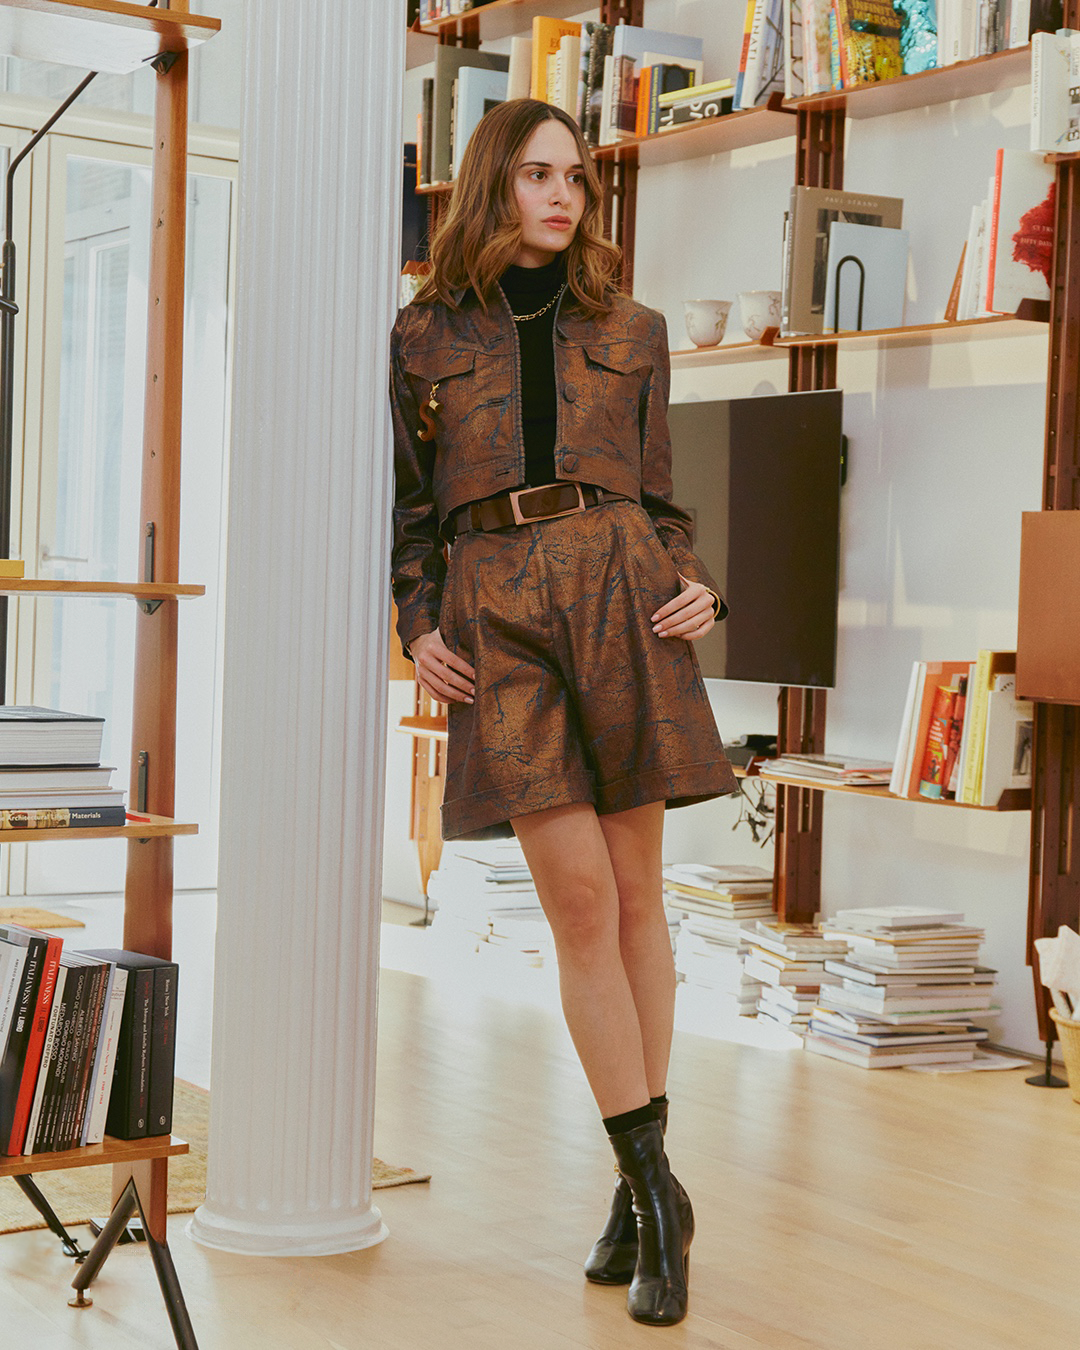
top-left (668, 389), bottom-right (842, 689)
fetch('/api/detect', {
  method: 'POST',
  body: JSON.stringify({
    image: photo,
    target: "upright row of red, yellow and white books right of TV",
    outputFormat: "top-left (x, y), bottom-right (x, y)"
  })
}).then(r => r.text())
top-left (890, 651), bottom-right (1034, 806)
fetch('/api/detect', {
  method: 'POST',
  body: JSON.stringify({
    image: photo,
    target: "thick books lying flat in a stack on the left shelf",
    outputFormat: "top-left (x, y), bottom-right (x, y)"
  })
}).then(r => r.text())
top-left (0, 705), bottom-right (127, 830)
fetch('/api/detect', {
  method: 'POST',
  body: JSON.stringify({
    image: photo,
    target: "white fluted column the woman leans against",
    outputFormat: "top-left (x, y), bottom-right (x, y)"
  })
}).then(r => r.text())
top-left (189, 0), bottom-right (405, 1256)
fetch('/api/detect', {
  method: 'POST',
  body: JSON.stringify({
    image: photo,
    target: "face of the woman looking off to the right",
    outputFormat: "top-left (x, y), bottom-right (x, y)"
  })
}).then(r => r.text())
top-left (513, 117), bottom-right (585, 267)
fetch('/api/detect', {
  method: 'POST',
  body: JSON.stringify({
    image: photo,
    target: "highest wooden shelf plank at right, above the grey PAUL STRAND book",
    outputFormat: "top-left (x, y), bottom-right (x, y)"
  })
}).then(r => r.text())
top-left (786, 46), bottom-right (1031, 117)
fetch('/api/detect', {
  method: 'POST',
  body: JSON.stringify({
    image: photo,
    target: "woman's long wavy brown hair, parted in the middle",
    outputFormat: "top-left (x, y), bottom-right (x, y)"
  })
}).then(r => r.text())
top-left (416, 99), bottom-right (622, 317)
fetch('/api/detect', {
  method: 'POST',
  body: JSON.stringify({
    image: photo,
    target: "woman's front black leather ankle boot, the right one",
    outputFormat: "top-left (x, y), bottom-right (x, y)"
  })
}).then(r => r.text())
top-left (610, 1121), bottom-right (694, 1327)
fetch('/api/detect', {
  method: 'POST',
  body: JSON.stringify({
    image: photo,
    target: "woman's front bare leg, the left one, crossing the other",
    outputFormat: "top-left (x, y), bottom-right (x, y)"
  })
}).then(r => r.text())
top-left (512, 802), bottom-right (650, 1116)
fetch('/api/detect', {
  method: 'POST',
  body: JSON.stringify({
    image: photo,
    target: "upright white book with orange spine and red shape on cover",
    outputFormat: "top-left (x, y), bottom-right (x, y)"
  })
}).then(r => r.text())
top-left (986, 149), bottom-right (1054, 315)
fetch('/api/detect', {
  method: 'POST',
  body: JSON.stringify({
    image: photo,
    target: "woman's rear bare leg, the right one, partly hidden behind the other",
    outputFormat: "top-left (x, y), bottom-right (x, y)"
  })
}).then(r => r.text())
top-left (597, 802), bottom-right (675, 1096)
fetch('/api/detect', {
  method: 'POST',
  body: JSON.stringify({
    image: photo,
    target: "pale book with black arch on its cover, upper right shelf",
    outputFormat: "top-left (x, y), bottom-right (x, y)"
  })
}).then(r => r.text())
top-left (822, 220), bottom-right (909, 332)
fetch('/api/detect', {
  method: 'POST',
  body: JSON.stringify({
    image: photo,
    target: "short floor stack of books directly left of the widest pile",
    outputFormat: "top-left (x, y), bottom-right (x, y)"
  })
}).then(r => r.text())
top-left (743, 919), bottom-right (848, 1035)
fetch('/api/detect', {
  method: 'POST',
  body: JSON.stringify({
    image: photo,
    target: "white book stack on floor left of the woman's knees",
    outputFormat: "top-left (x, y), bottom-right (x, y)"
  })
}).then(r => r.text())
top-left (428, 840), bottom-right (555, 967)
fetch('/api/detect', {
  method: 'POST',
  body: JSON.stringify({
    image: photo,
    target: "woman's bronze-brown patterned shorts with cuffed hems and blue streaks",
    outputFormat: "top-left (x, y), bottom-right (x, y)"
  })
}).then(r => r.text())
top-left (439, 501), bottom-right (736, 840)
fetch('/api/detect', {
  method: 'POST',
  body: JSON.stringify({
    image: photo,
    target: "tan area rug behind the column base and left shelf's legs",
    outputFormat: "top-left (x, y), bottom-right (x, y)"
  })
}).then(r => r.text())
top-left (0, 1079), bottom-right (431, 1233)
